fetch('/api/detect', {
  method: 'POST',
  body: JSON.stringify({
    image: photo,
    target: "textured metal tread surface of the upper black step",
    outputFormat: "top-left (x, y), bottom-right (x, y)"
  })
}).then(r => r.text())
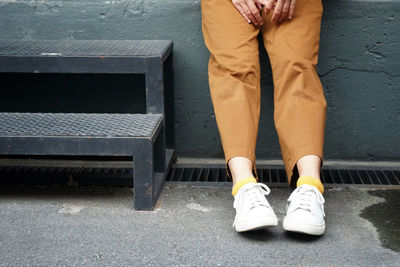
top-left (0, 39), bottom-right (172, 57)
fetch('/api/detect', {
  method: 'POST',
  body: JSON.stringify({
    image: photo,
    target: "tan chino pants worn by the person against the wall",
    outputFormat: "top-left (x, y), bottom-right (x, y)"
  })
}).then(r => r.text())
top-left (201, 0), bottom-right (327, 187)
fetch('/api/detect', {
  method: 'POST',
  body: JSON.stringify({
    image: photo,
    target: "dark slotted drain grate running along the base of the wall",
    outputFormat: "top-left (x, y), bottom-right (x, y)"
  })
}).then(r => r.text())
top-left (0, 161), bottom-right (400, 185)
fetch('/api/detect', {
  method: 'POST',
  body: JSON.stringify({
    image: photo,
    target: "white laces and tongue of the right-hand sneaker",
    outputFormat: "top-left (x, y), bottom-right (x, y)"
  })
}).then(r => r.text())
top-left (288, 186), bottom-right (325, 217)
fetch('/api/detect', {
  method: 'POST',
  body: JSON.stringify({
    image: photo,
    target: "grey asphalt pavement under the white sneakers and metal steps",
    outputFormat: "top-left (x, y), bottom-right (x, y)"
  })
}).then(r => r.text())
top-left (0, 182), bottom-right (400, 266)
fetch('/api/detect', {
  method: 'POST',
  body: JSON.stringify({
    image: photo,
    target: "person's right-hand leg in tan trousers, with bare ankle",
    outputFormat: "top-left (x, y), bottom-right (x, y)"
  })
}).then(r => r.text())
top-left (263, 0), bottom-right (327, 187)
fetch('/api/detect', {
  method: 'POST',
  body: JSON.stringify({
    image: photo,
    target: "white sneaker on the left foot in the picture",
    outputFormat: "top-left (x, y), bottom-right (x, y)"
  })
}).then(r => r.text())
top-left (233, 183), bottom-right (278, 232)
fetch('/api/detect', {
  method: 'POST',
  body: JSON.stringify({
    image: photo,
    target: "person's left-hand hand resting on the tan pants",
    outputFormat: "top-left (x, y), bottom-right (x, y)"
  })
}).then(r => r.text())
top-left (232, 0), bottom-right (276, 26)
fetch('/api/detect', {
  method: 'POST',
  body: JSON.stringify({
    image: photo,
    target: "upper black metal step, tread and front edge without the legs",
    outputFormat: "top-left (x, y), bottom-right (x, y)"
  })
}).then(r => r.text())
top-left (0, 39), bottom-right (172, 73)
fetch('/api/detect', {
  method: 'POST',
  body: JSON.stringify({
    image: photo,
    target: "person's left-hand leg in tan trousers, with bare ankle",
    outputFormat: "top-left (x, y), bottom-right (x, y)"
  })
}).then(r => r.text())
top-left (201, 0), bottom-right (260, 184)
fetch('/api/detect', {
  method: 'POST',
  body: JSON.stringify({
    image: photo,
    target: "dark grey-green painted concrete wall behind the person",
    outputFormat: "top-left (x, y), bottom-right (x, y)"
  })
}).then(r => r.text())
top-left (0, 0), bottom-right (400, 160)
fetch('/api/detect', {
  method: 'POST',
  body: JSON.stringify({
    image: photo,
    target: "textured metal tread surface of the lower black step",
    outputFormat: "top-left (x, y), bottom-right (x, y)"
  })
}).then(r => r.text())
top-left (0, 112), bottom-right (164, 137)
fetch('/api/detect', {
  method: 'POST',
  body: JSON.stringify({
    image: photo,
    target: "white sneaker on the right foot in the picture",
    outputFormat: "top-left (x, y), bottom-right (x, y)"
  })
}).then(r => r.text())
top-left (283, 184), bottom-right (325, 235)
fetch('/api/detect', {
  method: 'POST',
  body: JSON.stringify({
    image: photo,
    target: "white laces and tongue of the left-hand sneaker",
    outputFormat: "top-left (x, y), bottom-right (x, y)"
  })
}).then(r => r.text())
top-left (233, 183), bottom-right (271, 226)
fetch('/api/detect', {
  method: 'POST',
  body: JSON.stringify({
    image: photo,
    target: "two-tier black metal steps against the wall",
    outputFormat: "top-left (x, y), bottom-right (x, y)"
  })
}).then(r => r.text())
top-left (0, 39), bottom-right (175, 210)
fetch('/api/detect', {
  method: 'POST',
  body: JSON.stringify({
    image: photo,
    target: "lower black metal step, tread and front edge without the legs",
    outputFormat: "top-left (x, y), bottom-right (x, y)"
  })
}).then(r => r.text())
top-left (0, 112), bottom-right (164, 156)
